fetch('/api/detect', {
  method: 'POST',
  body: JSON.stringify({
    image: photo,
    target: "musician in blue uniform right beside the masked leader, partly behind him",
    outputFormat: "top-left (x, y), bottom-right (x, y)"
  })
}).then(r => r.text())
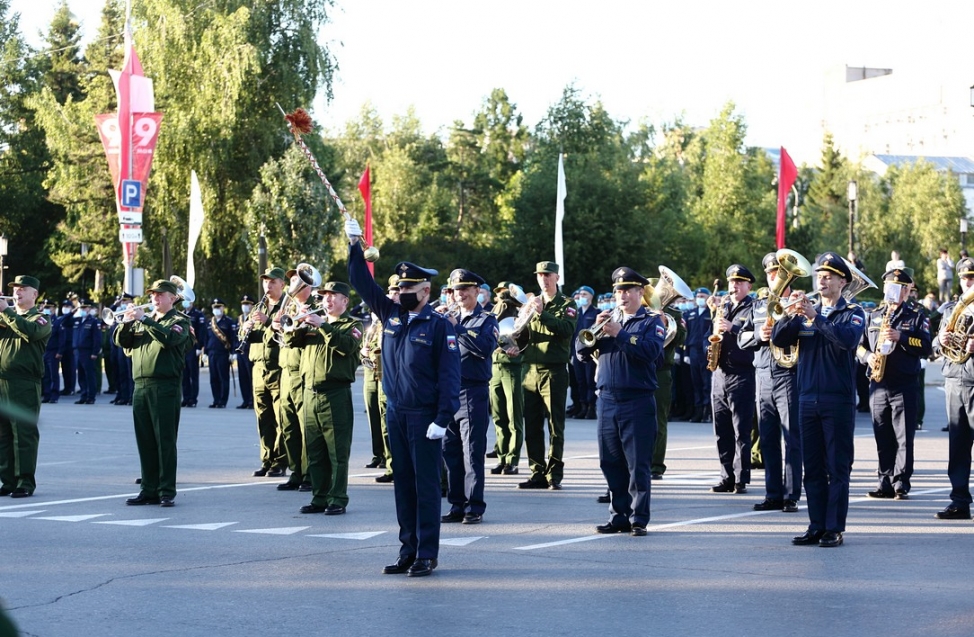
top-left (437, 268), bottom-right (499, 524)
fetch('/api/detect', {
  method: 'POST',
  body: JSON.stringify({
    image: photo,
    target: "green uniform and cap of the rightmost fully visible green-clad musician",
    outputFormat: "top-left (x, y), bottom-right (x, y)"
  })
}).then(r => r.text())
top-left (522, 262), bottom-right (576, 488)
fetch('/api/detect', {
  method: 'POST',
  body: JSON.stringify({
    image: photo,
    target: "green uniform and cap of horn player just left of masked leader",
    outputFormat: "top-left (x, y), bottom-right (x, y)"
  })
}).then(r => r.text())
top-left (287, 282), bottom-right (362, 508)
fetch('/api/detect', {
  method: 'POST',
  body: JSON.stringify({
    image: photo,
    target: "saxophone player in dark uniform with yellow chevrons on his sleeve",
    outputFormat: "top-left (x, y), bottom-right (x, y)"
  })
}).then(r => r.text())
top-left (856, 268), bottom-right (931, 500)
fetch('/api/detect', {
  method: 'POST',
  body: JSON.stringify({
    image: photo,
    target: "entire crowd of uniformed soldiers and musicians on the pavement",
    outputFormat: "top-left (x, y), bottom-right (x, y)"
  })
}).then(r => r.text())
top-left (0, 234), bottom-right (974, 577)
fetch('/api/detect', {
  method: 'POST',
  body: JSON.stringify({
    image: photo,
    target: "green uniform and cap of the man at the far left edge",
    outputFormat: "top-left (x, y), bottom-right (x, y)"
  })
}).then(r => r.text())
top-left (0, 276), bottom-right (51, 497)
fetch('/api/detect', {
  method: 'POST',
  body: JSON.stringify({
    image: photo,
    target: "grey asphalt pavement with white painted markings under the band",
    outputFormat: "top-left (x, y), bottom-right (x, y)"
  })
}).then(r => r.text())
top-left (0, 362), bottom-right (974, 637)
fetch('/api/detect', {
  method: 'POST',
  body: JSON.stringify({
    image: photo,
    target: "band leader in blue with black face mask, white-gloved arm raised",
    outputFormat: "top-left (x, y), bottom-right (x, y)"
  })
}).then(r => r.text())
top-left (345, 219), bottom-right (460, 577)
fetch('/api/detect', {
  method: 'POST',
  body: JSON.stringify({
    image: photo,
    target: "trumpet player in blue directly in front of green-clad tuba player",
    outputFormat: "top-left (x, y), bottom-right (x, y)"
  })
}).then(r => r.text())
top-left (576, 267), bottom-right (666, 537)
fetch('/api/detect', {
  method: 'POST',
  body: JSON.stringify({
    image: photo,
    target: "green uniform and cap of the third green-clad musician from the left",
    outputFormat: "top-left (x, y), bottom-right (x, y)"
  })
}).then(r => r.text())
top-left (247, 268), bottom-right (287, 476)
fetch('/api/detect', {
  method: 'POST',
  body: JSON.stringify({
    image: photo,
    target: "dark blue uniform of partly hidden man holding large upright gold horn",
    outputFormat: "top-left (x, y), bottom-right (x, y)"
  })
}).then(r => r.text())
top-left (738, 299), bottom-right (802, 502)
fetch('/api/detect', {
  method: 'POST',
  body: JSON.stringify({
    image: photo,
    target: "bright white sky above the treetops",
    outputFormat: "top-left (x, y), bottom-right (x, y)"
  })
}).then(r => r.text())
top-left (11, 0), bottom-right (974, 164)
